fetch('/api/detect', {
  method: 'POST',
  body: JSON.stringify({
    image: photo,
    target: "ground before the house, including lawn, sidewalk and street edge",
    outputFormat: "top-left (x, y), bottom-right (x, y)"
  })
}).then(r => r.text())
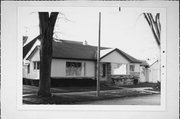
top-left (23, 82), bottom-right (160, 104)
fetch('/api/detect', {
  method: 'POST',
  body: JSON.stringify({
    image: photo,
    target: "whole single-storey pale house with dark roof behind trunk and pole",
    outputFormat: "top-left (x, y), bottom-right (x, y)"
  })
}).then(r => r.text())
top-left (23, 36), bottom-right (150, 85)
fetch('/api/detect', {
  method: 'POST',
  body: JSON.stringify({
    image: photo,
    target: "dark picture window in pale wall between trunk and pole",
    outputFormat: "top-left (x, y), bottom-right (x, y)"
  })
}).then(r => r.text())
top-left (66, 62), bottom-right (82, 76)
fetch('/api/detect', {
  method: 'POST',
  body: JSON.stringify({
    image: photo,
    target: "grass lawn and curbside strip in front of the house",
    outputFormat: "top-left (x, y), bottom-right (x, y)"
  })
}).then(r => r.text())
top-left (23, 83), bottom-right (160, 104)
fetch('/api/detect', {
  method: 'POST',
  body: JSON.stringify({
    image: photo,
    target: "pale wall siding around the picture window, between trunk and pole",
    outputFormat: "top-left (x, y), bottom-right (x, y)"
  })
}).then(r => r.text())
top-left (51, 59), bottom-right (95, 78)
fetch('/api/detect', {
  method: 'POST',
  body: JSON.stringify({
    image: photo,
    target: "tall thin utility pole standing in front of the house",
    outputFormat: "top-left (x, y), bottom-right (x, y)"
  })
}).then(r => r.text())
top-left (96, 12), bottom-right (101, 97)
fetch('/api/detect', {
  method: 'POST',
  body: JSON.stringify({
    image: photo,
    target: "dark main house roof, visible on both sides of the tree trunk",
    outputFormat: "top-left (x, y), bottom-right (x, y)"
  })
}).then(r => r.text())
top-left (23, 36), bottom-right (108, 60)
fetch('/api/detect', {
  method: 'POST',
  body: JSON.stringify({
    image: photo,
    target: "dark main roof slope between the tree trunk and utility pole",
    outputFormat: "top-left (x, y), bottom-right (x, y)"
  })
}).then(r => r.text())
top-left (53, 41), bottom-right (107, 60)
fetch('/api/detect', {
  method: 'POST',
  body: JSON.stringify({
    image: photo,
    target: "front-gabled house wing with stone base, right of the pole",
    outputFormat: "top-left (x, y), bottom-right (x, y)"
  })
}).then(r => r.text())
top-left (101, 48), bottom-right (141, 85)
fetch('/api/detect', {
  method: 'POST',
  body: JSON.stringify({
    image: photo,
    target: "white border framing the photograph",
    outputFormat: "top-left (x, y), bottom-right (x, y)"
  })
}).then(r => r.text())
top-left (16, 3), bottom-right (167, 111)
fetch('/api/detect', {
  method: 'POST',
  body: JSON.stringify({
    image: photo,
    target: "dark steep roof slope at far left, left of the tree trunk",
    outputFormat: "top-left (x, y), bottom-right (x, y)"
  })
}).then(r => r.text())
top-left (23, 35), bottom-right (40, 59)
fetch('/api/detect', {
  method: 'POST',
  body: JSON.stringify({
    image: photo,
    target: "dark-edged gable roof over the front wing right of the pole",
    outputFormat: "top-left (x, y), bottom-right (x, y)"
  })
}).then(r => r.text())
top-left (101, 48), bottom-right (141, 63)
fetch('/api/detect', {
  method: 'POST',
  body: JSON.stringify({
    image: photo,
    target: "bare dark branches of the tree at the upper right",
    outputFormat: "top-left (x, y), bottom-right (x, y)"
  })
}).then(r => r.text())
top-left (143, 13), bottom-right (161, 48)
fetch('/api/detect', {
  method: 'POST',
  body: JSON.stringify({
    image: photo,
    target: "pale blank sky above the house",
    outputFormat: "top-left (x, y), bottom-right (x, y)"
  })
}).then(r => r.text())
top-left (18, 7), bottom-right (165, 64)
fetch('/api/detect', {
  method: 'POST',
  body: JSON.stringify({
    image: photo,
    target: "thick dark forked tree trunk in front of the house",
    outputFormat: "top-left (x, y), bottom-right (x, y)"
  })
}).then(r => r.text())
top-left (38, 12), bottom-right (58, 97)
